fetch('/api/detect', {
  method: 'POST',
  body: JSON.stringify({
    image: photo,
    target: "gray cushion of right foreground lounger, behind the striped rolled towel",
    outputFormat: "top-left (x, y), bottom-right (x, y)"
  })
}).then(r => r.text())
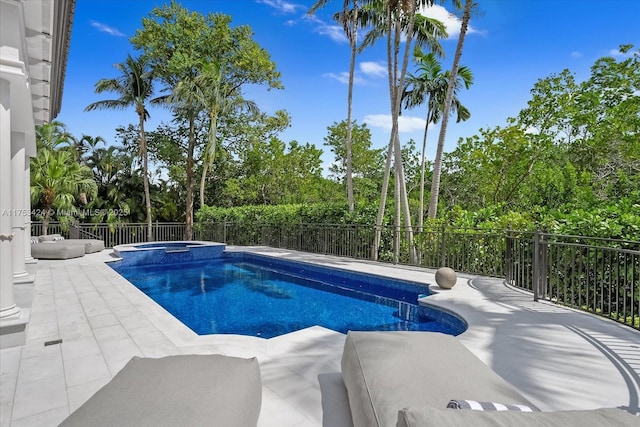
top-left (342, 332), bottom-right (532, 427)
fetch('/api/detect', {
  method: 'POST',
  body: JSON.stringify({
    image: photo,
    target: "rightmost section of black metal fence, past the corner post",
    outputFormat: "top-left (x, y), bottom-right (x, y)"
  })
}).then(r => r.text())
top-left (505, 232), bottom-right (640, 329)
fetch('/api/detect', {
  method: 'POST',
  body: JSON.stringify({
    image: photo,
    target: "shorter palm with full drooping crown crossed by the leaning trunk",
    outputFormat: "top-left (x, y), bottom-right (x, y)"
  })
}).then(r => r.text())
top-left (402, 46), bottom-right (473, 231)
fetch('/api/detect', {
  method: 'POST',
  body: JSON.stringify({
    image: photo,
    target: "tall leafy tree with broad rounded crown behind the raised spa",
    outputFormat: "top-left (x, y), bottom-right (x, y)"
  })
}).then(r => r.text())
top-left (131, 1), bottom-right (282, 239)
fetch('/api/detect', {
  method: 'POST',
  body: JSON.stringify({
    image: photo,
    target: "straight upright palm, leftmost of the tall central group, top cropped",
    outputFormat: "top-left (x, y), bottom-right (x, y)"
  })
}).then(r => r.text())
top-left (309, 0), bottom-right (359, 212)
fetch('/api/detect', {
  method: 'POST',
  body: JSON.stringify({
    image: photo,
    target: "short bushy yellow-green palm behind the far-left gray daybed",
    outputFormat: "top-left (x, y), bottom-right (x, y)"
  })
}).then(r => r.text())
top-left (31, 147), bottom-right (98, 234)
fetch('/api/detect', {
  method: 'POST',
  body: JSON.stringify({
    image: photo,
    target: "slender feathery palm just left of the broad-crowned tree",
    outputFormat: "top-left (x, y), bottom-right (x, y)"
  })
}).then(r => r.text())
top-left (85, 55), bottom-right (160, 241)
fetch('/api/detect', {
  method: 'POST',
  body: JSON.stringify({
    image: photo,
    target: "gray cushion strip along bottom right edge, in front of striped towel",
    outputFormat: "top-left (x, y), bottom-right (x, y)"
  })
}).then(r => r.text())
top-left (397, 406), bottom-right (640, 427)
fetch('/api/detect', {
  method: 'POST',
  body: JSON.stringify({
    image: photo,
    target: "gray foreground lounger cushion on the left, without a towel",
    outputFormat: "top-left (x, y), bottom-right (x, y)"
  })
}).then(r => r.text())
top-left (61, 354), bottom-right (262, 427)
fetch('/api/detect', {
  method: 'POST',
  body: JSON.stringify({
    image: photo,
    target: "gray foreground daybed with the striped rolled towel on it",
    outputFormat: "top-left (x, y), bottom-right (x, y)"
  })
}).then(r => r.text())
top-left (342, 331), bottom-right (640, 427)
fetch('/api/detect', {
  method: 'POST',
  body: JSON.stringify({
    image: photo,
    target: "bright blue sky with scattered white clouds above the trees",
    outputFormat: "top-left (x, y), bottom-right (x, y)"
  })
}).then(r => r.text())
top-left (57, 0), bottom-right (640, 172)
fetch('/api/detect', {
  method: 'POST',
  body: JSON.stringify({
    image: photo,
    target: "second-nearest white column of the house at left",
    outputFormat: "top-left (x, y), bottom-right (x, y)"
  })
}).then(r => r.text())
top-left (10, 132), bottom-right (33, 283)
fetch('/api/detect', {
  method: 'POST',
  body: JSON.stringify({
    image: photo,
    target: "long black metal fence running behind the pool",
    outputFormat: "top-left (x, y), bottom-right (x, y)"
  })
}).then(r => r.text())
top-left (32, 222), bottom-right (640, 329)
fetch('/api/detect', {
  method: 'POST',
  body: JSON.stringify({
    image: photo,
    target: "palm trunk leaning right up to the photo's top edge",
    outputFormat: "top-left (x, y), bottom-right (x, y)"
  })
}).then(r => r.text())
top-left (428, 0), bottom-right (473, 218)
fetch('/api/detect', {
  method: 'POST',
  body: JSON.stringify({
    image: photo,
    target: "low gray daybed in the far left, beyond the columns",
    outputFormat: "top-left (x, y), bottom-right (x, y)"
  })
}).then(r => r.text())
top-left (31, 234), bottom-right (104, 259)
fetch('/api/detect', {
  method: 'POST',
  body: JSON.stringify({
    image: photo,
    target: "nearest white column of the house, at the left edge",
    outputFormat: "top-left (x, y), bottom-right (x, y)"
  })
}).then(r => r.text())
top-left (0, 79), bottom-right (20, 318)
